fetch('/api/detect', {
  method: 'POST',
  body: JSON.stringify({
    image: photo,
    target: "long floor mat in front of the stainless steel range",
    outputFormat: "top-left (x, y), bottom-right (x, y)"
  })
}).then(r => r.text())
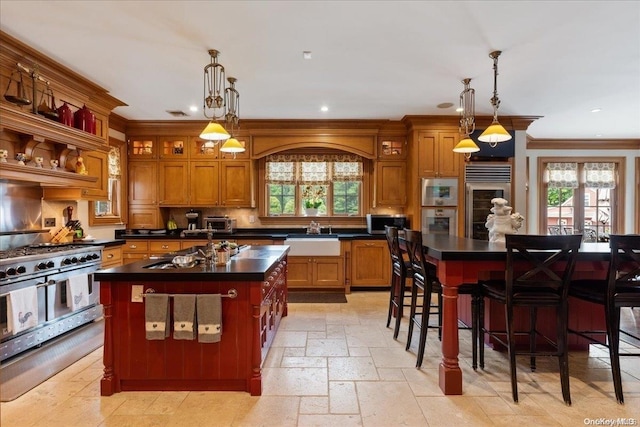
top-left (0, 320), bottom-right (104, 402)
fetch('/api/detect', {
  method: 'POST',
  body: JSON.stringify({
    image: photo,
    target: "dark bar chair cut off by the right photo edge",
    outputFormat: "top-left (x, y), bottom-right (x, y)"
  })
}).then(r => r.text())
top-left (569, 234), bottom-right (640, 404)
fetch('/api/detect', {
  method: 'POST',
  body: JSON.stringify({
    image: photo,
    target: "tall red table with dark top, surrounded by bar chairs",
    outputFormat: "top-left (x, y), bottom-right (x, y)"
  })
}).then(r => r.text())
top-left (422, 234), bottom-right (610, 395)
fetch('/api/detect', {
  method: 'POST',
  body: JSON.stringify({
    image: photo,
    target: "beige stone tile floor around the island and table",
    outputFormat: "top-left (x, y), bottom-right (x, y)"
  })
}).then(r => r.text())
top-left (0, 292), bottom-right (640, 427)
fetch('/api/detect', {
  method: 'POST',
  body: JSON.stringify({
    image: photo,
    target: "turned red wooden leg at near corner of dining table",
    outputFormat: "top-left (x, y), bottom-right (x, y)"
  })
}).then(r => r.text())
top-left (439, 283), bottom-right (462, 395)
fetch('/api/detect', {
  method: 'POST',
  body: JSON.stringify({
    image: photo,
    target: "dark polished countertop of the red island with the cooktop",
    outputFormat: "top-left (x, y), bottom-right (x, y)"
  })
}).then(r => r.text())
top-left (94, 245), bottom-right (289, 282)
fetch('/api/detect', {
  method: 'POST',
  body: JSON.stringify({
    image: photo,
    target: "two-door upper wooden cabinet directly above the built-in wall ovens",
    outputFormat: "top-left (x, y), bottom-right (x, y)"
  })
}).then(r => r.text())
top-left (418, 131), bottom-right (464, 178)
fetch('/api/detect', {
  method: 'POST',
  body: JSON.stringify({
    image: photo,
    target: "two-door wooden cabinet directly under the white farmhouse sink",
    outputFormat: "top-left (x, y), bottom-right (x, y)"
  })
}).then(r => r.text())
top-left (287, 256), bottom-right (344, 289)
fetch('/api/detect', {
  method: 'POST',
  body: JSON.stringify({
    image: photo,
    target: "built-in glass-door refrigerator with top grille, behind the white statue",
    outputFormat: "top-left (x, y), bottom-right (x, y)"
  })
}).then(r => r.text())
top-left (465, 163), bottom-right (512, 240)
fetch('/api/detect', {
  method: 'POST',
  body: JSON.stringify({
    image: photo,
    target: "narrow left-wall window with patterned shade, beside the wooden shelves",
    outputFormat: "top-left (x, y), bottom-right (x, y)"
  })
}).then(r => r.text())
top-left (89, 147), bottom-right (123, 225)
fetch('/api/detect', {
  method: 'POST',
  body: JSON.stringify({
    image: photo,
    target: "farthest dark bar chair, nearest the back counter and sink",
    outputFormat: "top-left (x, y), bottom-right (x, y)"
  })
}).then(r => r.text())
top-left (384, 225), bottom-right (413, 339)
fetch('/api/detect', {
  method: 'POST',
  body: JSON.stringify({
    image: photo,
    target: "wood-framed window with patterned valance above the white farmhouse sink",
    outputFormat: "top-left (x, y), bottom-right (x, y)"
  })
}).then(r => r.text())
top-left (265, 154), bottom-right (363, 216)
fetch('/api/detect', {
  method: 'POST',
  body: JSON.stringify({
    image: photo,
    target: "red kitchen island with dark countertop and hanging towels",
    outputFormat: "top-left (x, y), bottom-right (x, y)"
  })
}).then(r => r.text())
top-left (94, 245), bottom-right (289, 396)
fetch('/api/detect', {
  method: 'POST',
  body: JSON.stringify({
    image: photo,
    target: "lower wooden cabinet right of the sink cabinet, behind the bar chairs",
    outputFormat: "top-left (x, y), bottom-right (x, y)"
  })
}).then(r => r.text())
top-left (349, 240), bottom-right (391, 287)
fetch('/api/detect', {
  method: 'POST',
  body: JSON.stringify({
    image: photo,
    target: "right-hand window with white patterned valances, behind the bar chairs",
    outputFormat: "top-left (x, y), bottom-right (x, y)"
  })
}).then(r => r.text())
top-left (541, 161), bottom-right (620, 242)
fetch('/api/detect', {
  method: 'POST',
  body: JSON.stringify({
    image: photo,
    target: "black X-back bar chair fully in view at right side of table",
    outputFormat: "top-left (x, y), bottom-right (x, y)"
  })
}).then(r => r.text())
top-left (476, 234), bottom-right (582, 405)
